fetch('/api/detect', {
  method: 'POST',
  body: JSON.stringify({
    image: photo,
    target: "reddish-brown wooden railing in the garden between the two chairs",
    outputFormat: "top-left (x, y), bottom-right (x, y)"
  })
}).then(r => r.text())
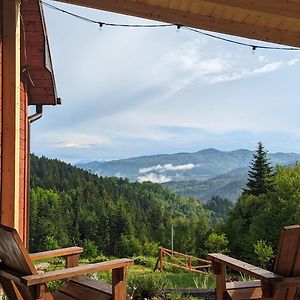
top-left (154, 247), bottom-right (211, 273)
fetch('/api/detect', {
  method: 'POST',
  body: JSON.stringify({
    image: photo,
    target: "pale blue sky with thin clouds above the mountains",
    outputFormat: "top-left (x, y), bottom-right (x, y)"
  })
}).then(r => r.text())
top-left (30, 0), bottom-right (300, 163)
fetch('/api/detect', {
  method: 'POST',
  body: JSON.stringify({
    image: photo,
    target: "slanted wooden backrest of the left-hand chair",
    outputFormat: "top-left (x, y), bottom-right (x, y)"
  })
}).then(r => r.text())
top-left (0, 225), bottom-right (37, 275)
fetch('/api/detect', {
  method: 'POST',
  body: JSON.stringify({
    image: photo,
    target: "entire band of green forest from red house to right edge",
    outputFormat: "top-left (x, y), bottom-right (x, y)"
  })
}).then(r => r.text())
top-left (30, 149), bottom-right (300, 267)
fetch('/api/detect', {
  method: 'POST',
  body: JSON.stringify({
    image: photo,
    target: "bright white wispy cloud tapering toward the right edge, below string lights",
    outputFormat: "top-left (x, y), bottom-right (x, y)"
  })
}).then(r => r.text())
top-left (140, 39), bottom-right (299, 101)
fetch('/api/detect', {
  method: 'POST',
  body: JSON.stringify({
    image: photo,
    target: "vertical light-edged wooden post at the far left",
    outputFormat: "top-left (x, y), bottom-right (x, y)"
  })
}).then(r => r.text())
top-left (1, 0), bottom-right (20, 230)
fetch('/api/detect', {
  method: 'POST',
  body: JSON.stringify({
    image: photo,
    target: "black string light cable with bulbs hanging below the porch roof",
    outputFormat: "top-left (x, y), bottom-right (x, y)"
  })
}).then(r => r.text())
top-left (41, 1), bottom-right (300, 51)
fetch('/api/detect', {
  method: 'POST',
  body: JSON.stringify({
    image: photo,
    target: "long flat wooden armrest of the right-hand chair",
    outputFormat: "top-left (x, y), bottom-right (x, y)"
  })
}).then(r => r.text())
top-left (208, 253), bottom-right (282, 283)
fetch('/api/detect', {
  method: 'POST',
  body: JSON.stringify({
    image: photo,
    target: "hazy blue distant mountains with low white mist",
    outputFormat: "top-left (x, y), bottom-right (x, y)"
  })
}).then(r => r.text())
top-left (76, 148), bottom-right (300, 201)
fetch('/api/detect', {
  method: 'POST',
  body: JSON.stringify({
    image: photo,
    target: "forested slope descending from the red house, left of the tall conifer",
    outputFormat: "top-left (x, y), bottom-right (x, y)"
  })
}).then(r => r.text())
top-left (30, 155), bottom-right (209, 256)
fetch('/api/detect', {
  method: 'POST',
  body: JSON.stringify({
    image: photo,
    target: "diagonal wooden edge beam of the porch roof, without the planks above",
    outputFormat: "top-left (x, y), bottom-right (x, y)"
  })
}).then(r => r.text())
top-left (57, 0), bottom-right (300, 47)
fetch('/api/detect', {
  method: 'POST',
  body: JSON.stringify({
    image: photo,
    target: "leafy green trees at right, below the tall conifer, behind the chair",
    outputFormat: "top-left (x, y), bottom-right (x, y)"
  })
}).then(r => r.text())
top-left (223, 165), bottom-right (300, 265)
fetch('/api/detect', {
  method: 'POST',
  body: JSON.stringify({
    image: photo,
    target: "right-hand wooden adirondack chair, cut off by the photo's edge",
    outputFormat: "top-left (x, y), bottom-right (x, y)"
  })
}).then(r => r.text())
top-left (208, 225), bottom-right (300, 300)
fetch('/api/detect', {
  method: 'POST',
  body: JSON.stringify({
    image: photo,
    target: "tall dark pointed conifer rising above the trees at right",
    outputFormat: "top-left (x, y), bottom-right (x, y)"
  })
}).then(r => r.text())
top-left (244, 142), bottom-right (274, 196)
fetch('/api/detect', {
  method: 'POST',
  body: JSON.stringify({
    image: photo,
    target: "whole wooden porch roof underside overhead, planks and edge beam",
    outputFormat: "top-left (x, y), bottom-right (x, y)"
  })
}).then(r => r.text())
top-left (58, 0), bottom-right (300, 47)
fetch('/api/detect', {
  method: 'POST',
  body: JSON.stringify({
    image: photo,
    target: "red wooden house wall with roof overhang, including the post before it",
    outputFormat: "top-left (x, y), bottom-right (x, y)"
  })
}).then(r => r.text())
top-left (0, 0), bottom-right (60, 245)
